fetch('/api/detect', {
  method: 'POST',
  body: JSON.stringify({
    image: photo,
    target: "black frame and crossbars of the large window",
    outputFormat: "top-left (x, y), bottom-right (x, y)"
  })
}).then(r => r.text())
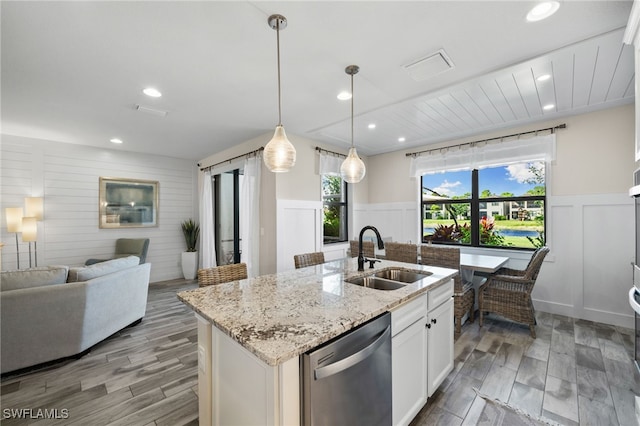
top-left (418, 164), bottom-right (548, 251)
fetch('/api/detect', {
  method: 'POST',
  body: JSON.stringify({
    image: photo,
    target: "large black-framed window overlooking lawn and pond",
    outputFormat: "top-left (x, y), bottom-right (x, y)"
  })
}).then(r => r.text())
top-left (421, 161), bottom-right (546, 249)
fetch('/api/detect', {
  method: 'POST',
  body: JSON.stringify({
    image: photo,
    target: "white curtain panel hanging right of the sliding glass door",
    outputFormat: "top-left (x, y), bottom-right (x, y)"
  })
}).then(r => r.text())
top-left (240, 152), bottom-right (262, 278)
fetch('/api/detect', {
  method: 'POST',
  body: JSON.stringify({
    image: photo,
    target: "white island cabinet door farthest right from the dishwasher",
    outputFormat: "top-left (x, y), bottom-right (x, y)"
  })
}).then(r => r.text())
top-left (426, 298), bottom-right (453, 396)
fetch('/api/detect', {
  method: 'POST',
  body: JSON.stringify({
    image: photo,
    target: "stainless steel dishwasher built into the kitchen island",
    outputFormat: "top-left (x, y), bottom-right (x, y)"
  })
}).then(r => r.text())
top-left (301, 312), bottom-right (391, 426)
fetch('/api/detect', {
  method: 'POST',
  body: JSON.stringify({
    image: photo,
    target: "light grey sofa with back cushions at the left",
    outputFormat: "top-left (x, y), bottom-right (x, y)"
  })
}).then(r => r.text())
top-left (0, 256), bottom-right (151, 374)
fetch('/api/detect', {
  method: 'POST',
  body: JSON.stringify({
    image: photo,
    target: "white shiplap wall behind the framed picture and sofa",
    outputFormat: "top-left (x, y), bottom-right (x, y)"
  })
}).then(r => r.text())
top-left (0, 135), bottom-right (197, 282)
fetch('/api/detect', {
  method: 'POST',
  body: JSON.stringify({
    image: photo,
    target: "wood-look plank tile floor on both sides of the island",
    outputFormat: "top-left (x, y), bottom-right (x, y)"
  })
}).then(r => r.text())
top-left (0, 280), bottom-right (640, 426)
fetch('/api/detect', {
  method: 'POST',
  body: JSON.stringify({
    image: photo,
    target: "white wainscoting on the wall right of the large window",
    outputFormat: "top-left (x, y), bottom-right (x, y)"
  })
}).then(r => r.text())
top-left (533, 194), bottom-right (636, 328)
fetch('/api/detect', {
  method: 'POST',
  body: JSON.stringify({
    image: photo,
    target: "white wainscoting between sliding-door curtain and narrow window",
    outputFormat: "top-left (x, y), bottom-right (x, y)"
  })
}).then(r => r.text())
top-left (276, 200), bottom-right (322, 272)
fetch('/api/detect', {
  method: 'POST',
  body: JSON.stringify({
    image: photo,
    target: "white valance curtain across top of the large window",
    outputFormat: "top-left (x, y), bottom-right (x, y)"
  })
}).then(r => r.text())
top-left (409, 133), bottom-right (556, 177)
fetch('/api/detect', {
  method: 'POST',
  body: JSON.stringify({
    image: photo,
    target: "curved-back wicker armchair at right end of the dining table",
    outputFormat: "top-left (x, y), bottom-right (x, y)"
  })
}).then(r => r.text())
top-left (478, 247), bottom-right (549, 339)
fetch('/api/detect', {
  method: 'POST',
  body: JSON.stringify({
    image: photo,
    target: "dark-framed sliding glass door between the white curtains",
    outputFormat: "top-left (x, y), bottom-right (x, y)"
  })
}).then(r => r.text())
top-left (214, 169), bottom-right (243, 265)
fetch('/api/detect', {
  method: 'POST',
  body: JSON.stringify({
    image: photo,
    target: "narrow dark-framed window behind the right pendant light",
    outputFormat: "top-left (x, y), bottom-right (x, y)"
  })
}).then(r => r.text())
top-left (322, 175), bottom-right (349, 244)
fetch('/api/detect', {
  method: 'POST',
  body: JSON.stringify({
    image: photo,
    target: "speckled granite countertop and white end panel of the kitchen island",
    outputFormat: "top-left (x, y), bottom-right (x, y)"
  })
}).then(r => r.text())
top-left (178, 258), bottom-right (458, 425)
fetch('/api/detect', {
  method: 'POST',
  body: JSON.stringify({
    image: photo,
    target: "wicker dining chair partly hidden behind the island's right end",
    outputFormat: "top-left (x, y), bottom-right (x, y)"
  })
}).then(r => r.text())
top-left (420, 244), bottom-right (476, 336)
